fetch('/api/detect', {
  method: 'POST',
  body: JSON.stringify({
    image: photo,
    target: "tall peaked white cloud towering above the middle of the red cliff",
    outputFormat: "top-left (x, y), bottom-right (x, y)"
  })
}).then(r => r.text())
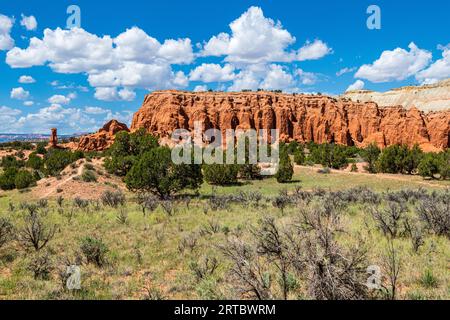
top-left (202, 7), bottom-right (331, 64)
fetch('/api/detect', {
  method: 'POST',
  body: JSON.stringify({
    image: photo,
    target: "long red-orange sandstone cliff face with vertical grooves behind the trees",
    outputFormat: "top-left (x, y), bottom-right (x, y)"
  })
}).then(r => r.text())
top-left (131, 91), bottom-right (450, 151)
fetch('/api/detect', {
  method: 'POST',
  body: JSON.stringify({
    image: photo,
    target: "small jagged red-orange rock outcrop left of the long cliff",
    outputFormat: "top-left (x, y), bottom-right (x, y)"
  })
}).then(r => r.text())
top-left (76, 120), bottom-right (129, 151)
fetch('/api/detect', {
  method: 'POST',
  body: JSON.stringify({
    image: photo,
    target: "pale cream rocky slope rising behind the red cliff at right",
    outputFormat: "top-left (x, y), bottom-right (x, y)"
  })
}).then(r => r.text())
top-left (343, 79), bottom-right (450, 111)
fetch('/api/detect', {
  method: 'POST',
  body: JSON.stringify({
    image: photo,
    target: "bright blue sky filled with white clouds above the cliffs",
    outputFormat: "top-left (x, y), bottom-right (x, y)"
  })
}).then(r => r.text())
top-left (0, 0), bottom-right (450, 134)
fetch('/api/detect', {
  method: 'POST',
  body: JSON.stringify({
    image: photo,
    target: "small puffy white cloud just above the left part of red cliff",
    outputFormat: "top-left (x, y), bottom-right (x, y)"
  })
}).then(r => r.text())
top-left (189, 63), bottom-right (236, 83)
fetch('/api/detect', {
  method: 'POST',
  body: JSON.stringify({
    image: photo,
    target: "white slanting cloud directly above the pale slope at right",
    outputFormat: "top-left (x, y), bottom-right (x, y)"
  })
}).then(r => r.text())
top-left (355, 42), bottom-right (432, 83)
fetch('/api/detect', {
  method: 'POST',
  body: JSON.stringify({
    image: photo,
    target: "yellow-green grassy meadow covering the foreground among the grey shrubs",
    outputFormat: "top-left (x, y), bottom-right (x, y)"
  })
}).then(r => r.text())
top-left (0, 167), bottom-right (450, 299)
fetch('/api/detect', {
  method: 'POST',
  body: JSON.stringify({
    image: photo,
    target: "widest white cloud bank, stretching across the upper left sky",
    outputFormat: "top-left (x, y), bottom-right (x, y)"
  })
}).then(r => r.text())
top-left (6, 27), bottom-right (194, 94)
